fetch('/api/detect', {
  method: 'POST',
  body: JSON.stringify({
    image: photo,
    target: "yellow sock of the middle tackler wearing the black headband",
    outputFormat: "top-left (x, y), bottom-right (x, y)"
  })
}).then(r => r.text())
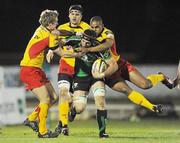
top-left (58, 102), bottom-right (69, 126)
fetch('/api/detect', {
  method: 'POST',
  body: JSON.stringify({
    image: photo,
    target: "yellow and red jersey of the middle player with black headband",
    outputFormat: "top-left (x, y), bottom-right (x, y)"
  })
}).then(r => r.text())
top-left (58, 21), bottom-right (90, 74)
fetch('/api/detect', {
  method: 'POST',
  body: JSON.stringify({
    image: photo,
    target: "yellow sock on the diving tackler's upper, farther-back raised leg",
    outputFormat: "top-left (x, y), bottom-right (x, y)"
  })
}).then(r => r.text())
top-left (147, 74), bottom-right (164, 86)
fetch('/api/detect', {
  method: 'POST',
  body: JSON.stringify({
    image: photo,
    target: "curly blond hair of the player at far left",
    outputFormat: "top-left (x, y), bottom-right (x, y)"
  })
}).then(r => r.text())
top-left (39, 9), bottom-right (59, 27)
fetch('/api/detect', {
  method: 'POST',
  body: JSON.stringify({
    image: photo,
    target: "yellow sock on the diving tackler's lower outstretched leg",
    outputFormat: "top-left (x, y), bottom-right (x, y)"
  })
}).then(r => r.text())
top-left (128, 90), bottom-right (154, 111)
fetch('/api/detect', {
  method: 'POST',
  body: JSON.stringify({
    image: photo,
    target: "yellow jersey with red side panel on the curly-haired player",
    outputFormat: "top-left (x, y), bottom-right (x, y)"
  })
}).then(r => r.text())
top-left (20, 26), bottom-right (58, 68)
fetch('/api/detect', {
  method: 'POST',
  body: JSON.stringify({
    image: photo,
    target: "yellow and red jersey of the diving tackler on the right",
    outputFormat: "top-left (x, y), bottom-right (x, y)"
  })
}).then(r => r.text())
top-left (96, 27), bottom-right (120, 61)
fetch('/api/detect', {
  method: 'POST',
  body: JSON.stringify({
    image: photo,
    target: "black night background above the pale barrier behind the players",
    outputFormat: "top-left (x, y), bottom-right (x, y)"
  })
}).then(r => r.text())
top-left (0, 0), bottom-right (180, 65)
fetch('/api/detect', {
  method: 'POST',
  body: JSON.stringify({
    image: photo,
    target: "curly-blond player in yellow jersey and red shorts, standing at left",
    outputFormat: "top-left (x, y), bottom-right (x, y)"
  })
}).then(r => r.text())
top-left (20, 10), bottom-right (59, 138)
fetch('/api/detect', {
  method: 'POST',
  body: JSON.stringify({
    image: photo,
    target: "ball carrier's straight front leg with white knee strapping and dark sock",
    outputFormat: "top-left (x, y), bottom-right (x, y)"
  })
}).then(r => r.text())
top-left (92, 81), bottom-right (109, 138)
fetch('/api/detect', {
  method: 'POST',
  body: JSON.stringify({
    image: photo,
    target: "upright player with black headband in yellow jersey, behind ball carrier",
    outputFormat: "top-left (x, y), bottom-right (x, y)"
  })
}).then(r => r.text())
top-left (47, 5), bottom-right (90, 135)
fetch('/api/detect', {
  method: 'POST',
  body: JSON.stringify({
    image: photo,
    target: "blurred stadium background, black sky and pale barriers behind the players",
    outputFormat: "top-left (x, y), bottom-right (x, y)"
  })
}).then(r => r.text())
top-left (0, 0), bottom-right (180, 131)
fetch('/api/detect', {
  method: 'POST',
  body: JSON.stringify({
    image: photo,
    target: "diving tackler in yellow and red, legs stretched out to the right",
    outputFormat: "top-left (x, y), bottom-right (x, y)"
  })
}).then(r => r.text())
top-left (77, 16), bottom-right (174, 112)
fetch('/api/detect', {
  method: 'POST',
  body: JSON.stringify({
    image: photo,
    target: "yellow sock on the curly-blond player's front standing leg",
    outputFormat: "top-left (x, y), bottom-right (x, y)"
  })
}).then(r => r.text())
top-left (39, 103), bottom-right (49, 135)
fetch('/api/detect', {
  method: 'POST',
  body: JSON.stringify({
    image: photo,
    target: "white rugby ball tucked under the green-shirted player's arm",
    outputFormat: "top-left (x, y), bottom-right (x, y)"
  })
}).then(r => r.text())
top-left (91, 58), bottom-right (108, 74)
